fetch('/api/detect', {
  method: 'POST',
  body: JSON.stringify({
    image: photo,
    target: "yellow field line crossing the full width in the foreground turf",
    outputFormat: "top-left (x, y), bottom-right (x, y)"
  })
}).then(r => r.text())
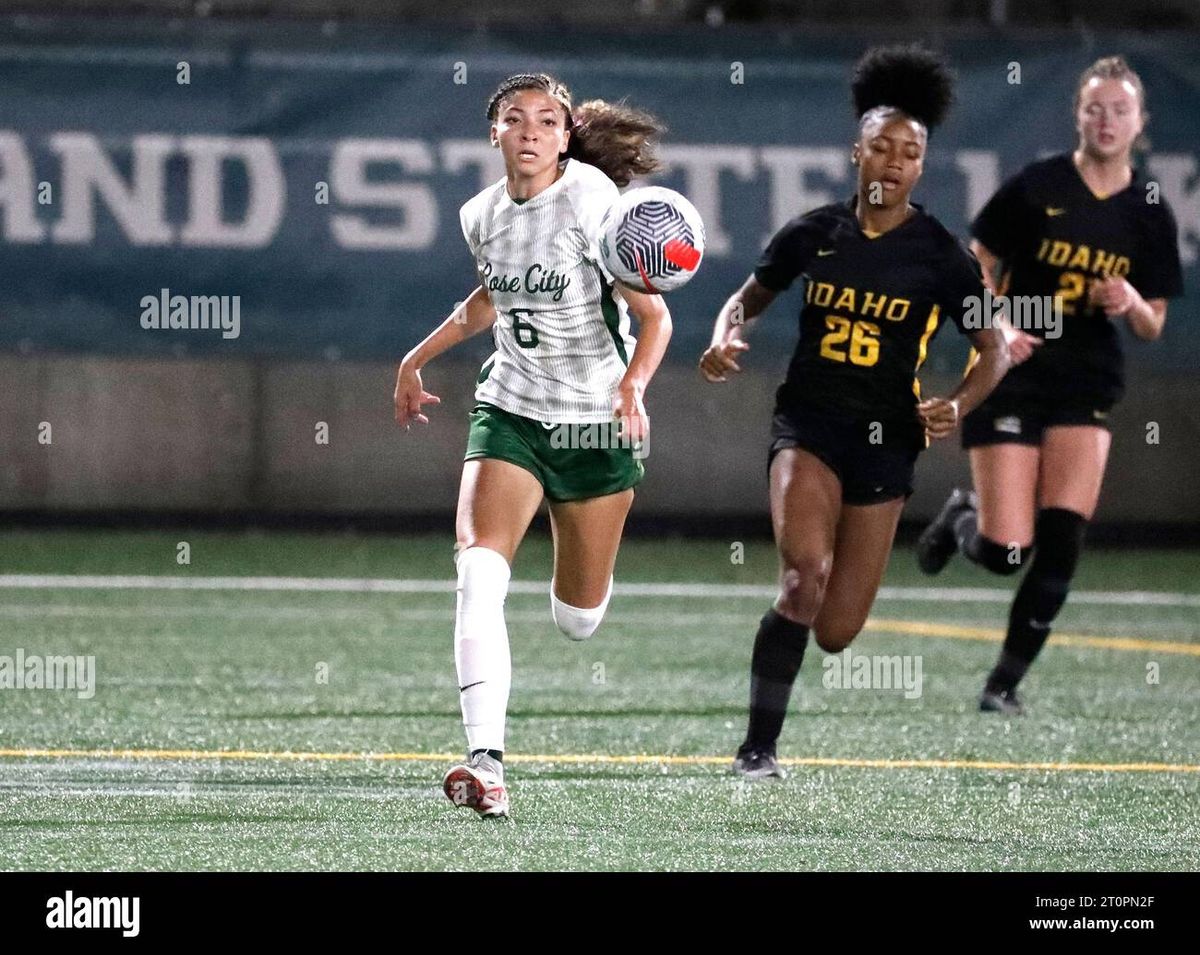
top-left (0, 749), bottom-right (1200, 773)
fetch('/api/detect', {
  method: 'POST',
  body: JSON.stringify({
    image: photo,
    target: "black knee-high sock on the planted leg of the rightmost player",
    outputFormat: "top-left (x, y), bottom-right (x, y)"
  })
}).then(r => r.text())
top-left (988, 507), bottom-right (1087, 690)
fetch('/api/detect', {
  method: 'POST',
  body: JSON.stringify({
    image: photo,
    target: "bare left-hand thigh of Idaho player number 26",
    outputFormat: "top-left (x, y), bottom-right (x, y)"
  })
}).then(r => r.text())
top-left (770, 448), bottom-right (841, 591)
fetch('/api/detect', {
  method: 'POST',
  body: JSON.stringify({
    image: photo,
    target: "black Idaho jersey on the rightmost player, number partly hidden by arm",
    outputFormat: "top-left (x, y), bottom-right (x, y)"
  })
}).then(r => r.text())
top-left (971, 154), bottom-right (1183, 407)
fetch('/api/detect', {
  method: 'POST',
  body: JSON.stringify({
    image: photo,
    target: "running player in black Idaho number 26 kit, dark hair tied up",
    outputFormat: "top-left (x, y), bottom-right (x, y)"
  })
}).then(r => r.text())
top-left (700, 42), bottom-right (1008, 777)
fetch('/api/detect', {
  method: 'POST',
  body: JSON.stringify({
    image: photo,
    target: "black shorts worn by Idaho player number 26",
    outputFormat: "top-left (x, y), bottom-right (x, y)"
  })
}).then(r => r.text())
top-left (767, 407), bottom-right (925, 506)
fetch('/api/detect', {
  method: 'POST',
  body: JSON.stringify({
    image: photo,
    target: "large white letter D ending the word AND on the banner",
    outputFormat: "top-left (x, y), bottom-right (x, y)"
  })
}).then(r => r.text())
top-left (179, 136), bottom-right (287, 248)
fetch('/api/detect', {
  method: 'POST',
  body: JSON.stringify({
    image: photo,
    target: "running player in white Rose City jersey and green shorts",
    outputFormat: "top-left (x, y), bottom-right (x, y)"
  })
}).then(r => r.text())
top-left (395, 73), bottom-right (671, 817)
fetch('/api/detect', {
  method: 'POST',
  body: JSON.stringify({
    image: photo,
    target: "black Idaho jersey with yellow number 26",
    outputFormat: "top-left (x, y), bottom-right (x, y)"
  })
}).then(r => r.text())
top-left (755, 198), bottom-right (983, 434)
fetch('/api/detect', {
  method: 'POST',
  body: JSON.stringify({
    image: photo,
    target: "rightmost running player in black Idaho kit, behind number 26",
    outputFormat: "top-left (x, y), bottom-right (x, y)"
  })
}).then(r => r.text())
top-left (917, 56), bottom-right (1183, 714)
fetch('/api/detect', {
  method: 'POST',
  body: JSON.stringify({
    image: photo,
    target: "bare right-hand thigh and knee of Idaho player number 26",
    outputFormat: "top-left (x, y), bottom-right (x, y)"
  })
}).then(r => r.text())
top-left (814, 498), bottom-right (905, 653)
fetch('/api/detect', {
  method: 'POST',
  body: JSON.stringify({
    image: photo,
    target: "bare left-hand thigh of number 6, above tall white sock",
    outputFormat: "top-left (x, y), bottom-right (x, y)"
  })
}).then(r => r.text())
top-left (455, 457), bottom-right (542, 564)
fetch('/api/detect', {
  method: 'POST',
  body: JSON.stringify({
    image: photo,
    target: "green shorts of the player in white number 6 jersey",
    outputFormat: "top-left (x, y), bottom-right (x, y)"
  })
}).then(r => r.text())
top-left (463, 403), bottom-right (646, 501)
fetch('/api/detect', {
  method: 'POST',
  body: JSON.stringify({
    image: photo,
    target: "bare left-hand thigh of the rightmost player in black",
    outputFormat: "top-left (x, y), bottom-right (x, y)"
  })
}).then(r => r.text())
top-left (970, 443), bottom-right (1042, 547)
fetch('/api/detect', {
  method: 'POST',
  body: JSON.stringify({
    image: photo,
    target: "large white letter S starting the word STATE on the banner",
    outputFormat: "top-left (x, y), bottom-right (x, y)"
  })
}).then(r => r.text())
top-left (329, 139), bottom-right (439, 250)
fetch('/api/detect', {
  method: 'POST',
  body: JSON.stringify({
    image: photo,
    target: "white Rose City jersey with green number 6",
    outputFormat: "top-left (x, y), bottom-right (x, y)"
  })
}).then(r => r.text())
top-left (458, 160), bottom-right (634, 425)
